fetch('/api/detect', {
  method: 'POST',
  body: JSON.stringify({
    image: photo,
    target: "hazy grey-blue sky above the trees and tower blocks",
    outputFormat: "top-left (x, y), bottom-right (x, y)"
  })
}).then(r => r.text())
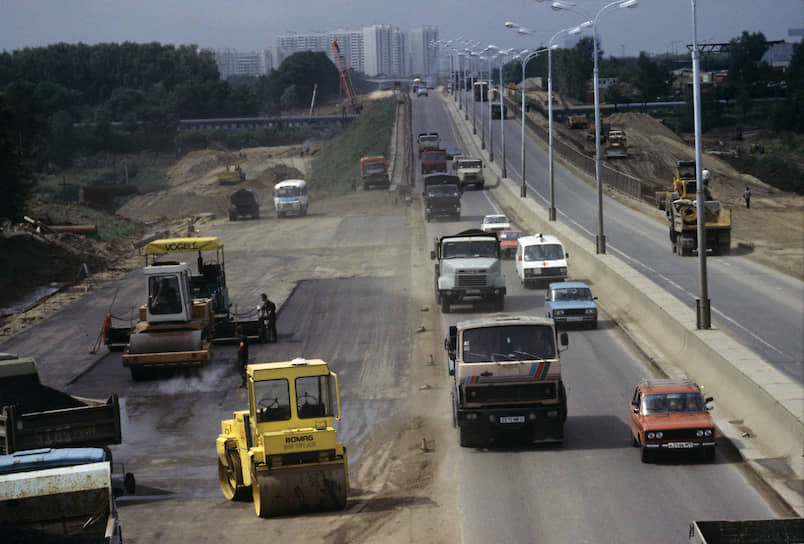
top-left (0, 0), bottom-right (804, 56)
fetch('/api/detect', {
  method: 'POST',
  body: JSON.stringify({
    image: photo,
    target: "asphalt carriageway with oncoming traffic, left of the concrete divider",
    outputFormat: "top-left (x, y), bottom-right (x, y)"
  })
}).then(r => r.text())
top-left (414, 91), bottom-right (774, 543)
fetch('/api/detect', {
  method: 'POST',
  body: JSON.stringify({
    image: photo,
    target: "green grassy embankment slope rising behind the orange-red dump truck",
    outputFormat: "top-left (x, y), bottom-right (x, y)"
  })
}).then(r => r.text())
top-left (310, 98), bottom-right (396, 196)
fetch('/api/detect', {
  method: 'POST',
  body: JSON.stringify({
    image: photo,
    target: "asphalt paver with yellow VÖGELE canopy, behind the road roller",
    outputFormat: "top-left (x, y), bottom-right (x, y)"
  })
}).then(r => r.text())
top-left (103, 236), bottom-right (275, 360)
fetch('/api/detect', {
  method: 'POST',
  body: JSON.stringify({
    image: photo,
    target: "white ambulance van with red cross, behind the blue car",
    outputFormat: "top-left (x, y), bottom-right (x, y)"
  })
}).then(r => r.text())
top-left (516, 233), bottom-right (569, 287)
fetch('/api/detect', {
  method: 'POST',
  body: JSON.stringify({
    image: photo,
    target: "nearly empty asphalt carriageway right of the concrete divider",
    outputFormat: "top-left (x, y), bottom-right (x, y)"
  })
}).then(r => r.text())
top-left (458, 90), bottom-right (804, 383)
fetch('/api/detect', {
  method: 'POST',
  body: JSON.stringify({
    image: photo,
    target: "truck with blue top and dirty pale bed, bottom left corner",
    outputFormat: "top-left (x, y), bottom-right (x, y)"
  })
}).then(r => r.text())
top-left (0, 448), bottom-right (122, 544)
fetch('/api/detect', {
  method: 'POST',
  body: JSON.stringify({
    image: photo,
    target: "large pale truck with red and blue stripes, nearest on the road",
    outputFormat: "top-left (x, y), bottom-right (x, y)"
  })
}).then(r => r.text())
top-left (444, 315), bottom-right (568, 447)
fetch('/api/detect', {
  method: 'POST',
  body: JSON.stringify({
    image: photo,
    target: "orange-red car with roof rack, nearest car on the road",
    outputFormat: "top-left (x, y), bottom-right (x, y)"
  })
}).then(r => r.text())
top-left (628, 379), bottom-right (715, 463)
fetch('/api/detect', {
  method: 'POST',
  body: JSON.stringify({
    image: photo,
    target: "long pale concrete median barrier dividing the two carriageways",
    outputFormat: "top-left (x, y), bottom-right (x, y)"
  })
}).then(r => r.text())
top-left (444, 89), bottom-right (804, 515)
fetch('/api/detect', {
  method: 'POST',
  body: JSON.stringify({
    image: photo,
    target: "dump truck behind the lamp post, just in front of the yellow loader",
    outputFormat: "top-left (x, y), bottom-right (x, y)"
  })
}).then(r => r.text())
top-left (665, 198), bottom-right (731, 256)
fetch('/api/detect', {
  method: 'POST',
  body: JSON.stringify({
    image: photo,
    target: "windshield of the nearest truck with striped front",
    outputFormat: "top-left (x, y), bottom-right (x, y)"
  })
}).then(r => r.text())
top-left (462, 325), bottom-right (556, 363)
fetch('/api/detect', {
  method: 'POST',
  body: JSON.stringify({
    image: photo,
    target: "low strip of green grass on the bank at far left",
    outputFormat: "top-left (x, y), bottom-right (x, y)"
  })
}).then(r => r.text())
top-left (26, 200), bottom-right (138, 242)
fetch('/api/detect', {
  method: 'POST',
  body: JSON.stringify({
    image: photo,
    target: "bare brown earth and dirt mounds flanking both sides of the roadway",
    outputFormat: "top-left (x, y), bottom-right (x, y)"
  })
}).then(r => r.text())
top-left (0, 92), bottom-right (804, 341)
